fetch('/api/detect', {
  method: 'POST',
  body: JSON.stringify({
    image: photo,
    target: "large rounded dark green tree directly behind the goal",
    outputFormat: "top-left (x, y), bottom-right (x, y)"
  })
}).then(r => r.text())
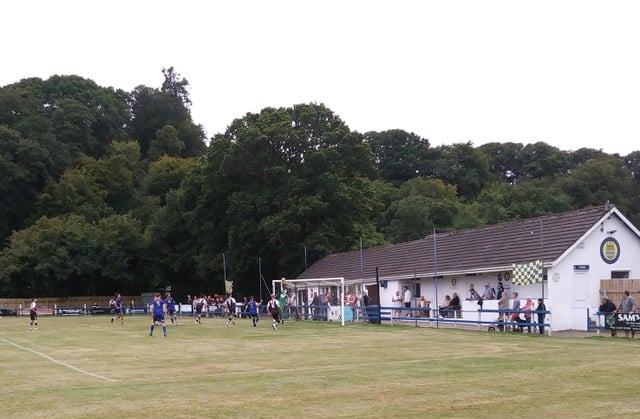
top-left (187, 104), bottom-right (379, 296)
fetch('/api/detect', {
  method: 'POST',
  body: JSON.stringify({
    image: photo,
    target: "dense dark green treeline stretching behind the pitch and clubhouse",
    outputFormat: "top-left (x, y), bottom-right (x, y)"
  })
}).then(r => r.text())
top-left (0, 68), bottom-right (640, 302)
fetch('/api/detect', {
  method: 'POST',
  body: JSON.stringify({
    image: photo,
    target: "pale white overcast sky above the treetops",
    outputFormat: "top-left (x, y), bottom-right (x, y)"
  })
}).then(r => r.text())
top-left (0, 0), bottom-right (640, 155)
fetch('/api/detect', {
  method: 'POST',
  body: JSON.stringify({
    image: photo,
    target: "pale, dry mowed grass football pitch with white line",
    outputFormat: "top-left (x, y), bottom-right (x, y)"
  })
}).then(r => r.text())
top-left (0, 316), bottom-right (640, 418)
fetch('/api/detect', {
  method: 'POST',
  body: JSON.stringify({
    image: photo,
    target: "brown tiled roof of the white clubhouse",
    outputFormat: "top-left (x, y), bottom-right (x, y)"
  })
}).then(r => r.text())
top-left (298, 207), bottom-right (608, 281)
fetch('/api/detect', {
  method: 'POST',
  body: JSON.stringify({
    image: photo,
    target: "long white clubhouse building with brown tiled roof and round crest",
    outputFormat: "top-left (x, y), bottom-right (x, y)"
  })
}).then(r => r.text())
top-left (298, 205), bottom-right (640, 331)
